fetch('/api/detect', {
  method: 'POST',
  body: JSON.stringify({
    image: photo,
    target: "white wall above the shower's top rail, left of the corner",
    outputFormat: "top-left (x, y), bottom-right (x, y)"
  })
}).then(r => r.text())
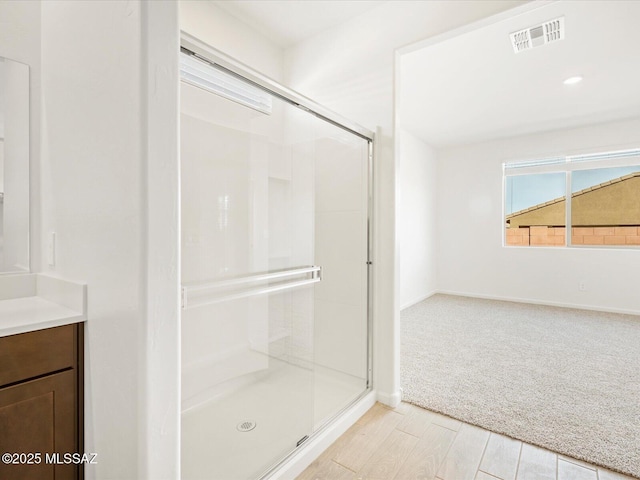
top-left (180, 0), bottom-right (283, 82)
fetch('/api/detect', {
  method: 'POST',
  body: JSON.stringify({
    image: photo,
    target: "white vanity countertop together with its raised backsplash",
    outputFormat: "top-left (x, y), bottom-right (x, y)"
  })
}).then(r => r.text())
top-left (0, 274), bottom-right (87, 337)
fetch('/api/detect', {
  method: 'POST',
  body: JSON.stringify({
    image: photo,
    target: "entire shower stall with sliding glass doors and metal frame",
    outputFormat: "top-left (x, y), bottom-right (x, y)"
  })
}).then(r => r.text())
top-left (180, 36), bottom-right (372, 480)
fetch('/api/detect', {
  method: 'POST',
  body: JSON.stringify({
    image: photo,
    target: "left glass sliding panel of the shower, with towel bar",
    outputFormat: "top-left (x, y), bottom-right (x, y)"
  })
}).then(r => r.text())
top-left (181, 78), bottom-right (315, 479)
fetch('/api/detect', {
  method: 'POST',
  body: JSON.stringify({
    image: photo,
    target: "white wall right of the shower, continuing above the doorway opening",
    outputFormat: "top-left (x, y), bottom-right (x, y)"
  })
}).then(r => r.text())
top-left (285, 1), bottom-right (524, 404)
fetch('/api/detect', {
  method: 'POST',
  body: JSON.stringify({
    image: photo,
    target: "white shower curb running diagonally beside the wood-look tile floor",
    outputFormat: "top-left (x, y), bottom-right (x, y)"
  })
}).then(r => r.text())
top-left (267, 391), bottom-right (377, 480)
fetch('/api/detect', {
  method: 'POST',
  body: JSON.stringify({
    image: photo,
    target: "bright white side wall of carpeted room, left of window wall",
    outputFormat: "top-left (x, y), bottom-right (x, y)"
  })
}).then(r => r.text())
top-left (397, 130), bottom-right (437, 309)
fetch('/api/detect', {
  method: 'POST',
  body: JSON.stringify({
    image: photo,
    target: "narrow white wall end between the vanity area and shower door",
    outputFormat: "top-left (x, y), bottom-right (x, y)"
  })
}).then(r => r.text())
top-left (138, 2), bottom-right (181, 480)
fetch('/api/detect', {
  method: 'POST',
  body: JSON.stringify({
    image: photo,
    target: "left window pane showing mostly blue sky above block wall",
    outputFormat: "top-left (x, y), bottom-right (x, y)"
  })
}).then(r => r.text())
top-left (505, 173), bottom-right (566, 247)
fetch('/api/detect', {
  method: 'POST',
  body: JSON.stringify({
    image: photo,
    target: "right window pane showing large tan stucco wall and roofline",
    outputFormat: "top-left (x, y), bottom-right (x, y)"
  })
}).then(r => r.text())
top-left (571, 165), bottom-right (640, 246)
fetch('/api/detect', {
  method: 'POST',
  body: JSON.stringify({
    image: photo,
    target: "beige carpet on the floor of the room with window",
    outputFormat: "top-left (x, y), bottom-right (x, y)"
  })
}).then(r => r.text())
top-left (401, 295), bottom-right (640, 478)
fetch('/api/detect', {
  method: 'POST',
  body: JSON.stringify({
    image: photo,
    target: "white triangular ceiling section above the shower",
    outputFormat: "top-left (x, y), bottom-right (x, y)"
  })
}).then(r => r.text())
top-left (211, 0), bottom-right (385, 47)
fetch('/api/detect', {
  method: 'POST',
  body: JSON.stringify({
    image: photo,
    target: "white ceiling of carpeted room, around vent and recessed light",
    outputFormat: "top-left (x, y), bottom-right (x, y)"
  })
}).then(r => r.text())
top-left (398, 1), bottom-right (640, 147)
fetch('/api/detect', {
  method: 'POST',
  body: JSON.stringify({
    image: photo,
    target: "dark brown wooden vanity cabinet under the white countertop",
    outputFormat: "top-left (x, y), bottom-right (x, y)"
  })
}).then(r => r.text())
top-left (0, 323), bottom-right (84, 480)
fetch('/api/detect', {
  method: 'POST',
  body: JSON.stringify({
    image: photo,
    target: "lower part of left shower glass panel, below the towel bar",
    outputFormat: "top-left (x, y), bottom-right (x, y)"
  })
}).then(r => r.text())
top-left (182, 286), bottom-right (314, 479)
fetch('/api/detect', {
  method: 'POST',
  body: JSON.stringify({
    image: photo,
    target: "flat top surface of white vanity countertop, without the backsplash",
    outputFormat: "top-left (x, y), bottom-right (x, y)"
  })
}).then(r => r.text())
top-left (0, 297), bottom-right (85, 337)
